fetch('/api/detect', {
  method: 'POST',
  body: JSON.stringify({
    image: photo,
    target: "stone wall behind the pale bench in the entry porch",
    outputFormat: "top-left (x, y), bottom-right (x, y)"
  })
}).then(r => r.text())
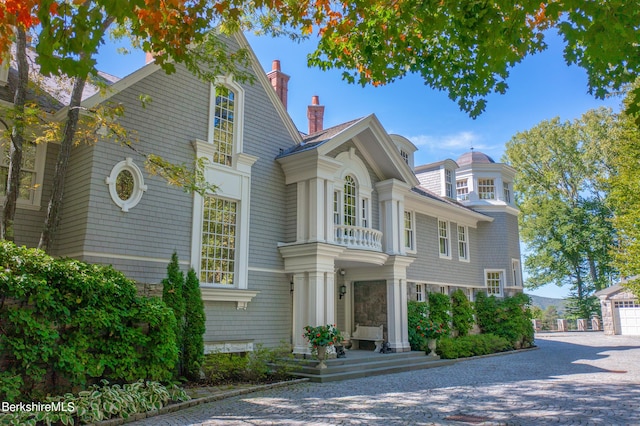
top-left (353, 281), bottom-right (388, 349)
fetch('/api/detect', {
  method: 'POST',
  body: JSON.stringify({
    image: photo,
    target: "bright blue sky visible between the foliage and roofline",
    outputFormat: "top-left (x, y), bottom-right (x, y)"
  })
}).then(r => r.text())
top-left (98, 30), bottom-right (620, 297)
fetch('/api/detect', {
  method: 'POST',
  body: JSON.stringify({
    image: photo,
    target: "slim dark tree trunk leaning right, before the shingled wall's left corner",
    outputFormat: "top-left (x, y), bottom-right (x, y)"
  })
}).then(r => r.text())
top-left (38, 77), bottom-right (87, 251)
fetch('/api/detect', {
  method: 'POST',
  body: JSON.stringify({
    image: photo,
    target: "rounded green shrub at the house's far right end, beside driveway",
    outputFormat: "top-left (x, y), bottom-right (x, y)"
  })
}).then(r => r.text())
top-left (475, 293), bottom-right (534, 349)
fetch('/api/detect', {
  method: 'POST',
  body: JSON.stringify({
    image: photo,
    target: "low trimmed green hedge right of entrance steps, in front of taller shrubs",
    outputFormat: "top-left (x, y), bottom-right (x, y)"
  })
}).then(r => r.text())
top-left (436, 334), bottom-right (511, 359)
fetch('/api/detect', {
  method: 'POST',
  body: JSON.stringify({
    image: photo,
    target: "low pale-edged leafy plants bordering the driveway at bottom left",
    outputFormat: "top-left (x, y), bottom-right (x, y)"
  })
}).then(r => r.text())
top-left (0, 380), bottom-right (190, 425)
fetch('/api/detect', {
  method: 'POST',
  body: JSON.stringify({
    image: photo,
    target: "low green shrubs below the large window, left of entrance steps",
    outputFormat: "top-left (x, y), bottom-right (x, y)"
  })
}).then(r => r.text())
top-left (203, 345), bottom-right (293, 385)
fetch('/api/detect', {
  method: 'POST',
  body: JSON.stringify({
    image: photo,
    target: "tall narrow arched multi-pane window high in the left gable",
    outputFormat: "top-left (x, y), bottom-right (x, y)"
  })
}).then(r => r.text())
top-left (213, 86), bottom-right (235, 166)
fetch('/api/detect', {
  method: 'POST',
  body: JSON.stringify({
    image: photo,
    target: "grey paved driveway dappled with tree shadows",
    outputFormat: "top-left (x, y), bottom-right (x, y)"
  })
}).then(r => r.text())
top-left (131, 332), bottom-right (640, 426)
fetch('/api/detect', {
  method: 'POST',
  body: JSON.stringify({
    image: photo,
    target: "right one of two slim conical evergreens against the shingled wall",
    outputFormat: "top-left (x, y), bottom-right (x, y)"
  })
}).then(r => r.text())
top-left (183, 268), bottom-right (206, 380)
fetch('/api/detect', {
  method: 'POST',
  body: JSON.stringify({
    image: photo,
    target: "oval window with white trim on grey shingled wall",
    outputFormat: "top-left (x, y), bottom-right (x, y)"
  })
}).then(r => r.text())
top-left (105, 157), bottom-right (147, 212)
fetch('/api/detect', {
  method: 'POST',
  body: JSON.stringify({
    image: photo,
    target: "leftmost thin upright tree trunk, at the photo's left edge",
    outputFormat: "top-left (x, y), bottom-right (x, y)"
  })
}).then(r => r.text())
top-left (0, 26), bottom-right (29, 241)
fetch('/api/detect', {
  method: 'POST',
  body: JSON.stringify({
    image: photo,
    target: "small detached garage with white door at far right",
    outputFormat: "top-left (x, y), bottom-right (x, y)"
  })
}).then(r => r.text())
top-left (596, 284), bottom-right (640, 336)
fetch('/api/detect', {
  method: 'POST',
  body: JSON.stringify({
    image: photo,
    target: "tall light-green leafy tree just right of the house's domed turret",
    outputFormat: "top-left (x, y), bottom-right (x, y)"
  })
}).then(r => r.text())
top-left (504, 109), bottom-right (616, 300)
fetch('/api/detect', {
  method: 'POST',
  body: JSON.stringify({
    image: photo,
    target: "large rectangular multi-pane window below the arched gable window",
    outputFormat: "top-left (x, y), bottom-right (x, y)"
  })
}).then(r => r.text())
top-left (200, 196), bottom-right (238, 285)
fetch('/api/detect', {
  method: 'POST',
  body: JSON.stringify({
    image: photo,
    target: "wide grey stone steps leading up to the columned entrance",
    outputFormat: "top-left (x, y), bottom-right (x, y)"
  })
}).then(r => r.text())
top-left (292, 352), bottom-right (456, 383)
